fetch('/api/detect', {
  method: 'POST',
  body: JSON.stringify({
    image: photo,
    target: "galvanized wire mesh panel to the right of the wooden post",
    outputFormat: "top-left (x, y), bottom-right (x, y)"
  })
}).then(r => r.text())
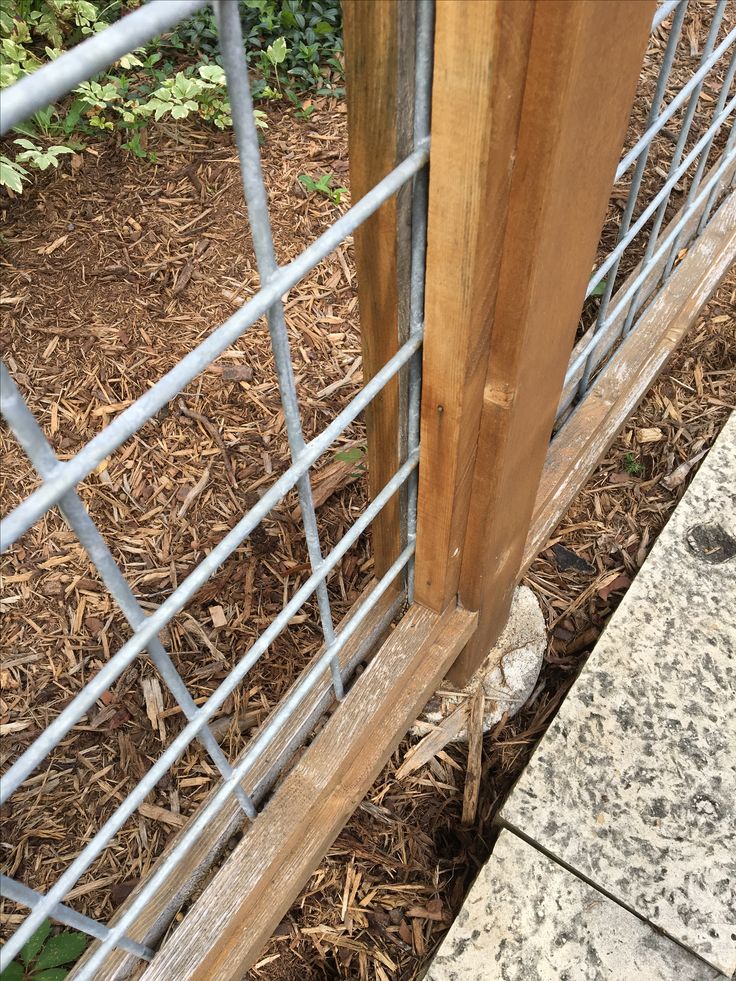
top-left (557, 0), bottom-right (736, 428)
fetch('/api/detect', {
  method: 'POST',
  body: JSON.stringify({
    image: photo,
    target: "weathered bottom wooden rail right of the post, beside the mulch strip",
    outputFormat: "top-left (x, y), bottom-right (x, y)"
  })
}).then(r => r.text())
top-left (523, 192), bottom-right (736, 570)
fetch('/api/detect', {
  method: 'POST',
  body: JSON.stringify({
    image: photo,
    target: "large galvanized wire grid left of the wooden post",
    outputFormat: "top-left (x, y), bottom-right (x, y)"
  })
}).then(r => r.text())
top-left (0, 0), bottom-right (433, 979)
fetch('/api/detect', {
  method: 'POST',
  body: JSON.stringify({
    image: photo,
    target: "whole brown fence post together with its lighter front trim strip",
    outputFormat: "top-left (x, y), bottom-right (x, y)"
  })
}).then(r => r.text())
top-left (416, 0), bottom-right (655, 683)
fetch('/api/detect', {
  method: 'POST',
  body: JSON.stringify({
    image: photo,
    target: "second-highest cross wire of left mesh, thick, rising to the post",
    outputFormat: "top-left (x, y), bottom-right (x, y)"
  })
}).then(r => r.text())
top-left (0, 141), bottom-right (429, 551)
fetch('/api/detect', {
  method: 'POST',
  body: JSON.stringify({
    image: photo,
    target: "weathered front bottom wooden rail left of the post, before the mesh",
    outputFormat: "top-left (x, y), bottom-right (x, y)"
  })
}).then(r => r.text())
top-left (143, 606), bottom-right (477, 981)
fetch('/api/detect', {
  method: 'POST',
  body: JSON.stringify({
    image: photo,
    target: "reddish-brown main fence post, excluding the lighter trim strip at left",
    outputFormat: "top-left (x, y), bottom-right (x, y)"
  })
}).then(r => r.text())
top-left (450, 0), bottom-right (655, 684)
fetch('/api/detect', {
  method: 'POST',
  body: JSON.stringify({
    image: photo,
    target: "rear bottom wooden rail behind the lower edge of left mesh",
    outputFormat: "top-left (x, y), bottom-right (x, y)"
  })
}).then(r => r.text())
top-left (70, 586), bottom-right (401, 981)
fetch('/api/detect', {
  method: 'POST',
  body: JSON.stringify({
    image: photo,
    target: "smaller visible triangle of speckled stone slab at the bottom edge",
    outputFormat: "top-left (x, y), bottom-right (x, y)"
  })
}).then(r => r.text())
top-left (425, 831), bottom-right (720, 981)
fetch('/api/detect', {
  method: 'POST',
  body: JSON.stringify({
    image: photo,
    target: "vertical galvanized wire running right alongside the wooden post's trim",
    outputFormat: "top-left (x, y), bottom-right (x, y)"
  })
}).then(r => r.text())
top-left (406, 0), bottom-right (434, 604)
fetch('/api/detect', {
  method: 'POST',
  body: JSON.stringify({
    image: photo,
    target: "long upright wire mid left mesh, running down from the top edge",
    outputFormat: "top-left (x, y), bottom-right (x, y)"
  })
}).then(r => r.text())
top-left (213, 0), bottom-right (344, 700)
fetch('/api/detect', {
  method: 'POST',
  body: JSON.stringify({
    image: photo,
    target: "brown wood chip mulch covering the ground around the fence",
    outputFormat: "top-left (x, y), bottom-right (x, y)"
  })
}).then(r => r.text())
top-left (0, 4), bottom-right (736, 981)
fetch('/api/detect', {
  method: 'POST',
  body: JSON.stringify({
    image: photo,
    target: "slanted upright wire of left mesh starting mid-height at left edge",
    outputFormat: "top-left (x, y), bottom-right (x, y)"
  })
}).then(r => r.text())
top-left (0, 362), bottom-right (256, 818)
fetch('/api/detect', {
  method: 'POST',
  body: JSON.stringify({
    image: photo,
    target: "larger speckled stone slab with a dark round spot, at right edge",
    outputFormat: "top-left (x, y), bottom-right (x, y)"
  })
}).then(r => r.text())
top-left (502, 414), bottom-right (736, 976)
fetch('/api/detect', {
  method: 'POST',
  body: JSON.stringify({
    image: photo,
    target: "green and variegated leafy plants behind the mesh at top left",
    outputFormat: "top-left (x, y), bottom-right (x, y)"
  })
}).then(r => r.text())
top-left (0, 0), bottom-right (343, 194)
